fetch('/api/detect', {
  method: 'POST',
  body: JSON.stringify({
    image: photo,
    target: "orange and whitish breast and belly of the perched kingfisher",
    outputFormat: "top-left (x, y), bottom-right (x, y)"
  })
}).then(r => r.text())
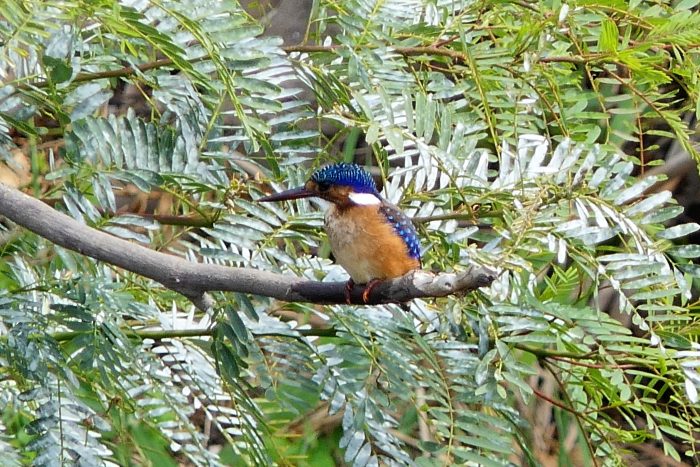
top-left (326, 205), bottom-right (420, 284)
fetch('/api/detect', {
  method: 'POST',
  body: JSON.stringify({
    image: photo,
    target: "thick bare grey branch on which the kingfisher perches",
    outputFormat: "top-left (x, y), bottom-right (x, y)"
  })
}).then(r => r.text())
top-left (0, 183), bottom-right (495, 308)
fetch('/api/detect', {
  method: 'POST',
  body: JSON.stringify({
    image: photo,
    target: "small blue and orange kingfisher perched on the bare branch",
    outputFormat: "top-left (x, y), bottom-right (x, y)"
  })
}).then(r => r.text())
top-left (258, 162), bottom-right (420, 304)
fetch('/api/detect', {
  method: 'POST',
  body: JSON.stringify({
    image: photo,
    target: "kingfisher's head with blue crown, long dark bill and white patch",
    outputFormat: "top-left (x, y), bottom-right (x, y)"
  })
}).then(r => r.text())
top-left (258, 162), bottom-right (381, 208)
